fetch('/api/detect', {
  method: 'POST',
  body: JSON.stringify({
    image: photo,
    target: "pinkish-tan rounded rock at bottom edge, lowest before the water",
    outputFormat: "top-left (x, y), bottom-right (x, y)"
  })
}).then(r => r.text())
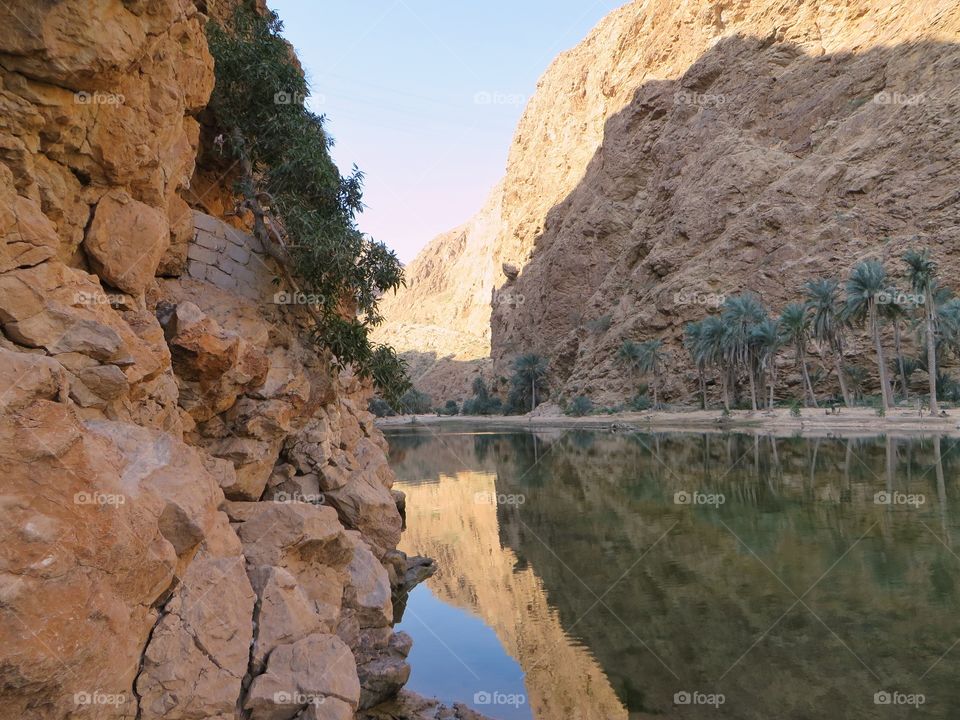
top-left (244, 633), bottom-right (360, 720)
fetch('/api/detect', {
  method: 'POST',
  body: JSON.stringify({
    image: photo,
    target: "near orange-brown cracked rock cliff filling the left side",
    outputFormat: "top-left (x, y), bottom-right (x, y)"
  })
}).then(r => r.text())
top-left (0, 0), bottom-right (480, 720)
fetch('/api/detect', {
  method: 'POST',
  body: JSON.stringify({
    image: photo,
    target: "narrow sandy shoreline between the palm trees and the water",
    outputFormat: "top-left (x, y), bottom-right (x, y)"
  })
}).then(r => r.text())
top-left (376, 408), bottom-right (960, 437)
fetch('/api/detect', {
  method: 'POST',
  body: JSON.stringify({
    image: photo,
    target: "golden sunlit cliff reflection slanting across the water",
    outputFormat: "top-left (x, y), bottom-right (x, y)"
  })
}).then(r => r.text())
top-left (396, 464), bottom-right (626, 720)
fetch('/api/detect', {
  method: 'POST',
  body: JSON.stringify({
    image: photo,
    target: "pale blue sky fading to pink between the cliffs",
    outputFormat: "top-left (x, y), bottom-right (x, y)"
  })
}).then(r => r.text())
top-left (268, 0), bottom-right (624, 263)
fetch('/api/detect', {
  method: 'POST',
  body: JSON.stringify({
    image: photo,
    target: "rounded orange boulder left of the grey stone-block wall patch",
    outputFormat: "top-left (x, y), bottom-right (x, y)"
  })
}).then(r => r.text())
top-left (83, 190), bottom-right (170, 295)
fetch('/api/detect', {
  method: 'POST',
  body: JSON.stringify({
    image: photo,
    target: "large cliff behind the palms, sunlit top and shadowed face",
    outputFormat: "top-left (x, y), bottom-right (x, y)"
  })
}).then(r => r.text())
top-left (376, 0), bottom-right (960, 401)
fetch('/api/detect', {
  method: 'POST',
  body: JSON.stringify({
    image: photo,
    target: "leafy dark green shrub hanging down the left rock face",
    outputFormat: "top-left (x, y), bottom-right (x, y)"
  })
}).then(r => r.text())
top-left (206, 8), bottom-right (410, 407)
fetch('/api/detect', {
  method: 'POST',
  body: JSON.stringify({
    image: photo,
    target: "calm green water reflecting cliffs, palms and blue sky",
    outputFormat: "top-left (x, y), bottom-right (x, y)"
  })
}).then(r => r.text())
top-left (388, 428), bottom-right (960, 720)
